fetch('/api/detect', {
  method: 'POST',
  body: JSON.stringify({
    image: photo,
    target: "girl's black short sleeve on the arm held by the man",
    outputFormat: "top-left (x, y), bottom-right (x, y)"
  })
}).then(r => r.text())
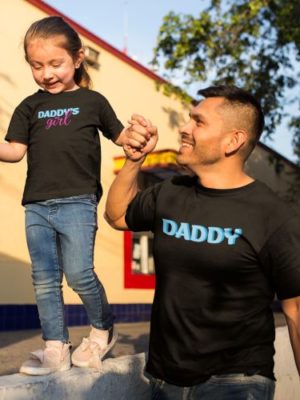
top-left (99, 96), bottom-right (124, 140)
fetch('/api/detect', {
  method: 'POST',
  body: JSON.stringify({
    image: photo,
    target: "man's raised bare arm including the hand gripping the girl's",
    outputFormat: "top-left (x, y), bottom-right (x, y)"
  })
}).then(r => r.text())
top-left (104, 115), bottom-right (158, 230)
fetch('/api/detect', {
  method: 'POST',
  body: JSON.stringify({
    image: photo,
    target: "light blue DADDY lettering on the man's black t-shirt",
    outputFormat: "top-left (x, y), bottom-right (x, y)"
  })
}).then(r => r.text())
top-left (162, 219), bottom-right (243, 245)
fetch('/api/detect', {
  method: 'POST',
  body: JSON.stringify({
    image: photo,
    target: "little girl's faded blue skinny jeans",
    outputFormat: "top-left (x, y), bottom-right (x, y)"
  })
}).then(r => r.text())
top-left (25, 195), bottom-right (113, 342)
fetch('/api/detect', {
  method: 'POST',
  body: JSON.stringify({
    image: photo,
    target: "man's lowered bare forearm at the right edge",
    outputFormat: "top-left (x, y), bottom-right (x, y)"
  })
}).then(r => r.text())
top-left (281, 297), bottom-right (300, 375)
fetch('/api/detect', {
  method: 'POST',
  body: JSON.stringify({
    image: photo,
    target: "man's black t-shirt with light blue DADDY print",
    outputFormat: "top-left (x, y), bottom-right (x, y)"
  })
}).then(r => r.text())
top-left (126, 177), bottom-right (300, 386)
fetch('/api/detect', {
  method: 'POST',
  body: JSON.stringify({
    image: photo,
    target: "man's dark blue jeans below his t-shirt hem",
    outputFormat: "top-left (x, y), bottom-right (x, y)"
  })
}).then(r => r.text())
top-left (150, 374), bottom-right (275, 400)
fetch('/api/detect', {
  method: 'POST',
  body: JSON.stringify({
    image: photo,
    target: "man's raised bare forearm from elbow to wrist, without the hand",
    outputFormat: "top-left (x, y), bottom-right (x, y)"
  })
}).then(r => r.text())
top-left (105, 158), bottom-right (144, 229)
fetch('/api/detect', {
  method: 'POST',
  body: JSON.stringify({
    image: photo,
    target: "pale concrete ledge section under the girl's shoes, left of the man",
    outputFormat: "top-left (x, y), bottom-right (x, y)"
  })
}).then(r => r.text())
top-left (0, 354), bottom-right (149, 400)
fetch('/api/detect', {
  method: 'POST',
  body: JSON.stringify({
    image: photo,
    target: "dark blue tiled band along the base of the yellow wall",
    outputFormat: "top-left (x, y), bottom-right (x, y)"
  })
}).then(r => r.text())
top-left (0, 304), bottom-right (151, 331)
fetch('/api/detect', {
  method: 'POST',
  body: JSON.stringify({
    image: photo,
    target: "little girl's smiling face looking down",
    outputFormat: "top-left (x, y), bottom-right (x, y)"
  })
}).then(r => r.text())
top-left (27, 36), bottom-right (84, 94)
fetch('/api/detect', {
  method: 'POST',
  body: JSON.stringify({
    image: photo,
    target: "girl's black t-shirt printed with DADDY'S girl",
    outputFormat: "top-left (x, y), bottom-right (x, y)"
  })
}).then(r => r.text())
top-left (5, 88), bottom-right (123, 204)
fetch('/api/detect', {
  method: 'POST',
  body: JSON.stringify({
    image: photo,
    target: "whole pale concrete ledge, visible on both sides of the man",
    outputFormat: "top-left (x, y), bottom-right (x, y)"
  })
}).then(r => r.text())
top-left (0, 327), bottom-right (300, 400)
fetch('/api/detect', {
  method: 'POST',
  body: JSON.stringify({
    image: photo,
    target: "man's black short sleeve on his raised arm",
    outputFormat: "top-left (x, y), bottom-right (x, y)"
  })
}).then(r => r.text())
top-left (126, 183), bottom-right (161, 232)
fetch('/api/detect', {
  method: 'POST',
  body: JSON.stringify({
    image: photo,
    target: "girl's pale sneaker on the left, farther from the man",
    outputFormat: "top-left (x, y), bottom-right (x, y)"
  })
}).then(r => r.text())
top-left (20, 340), bottom-right (71, 375)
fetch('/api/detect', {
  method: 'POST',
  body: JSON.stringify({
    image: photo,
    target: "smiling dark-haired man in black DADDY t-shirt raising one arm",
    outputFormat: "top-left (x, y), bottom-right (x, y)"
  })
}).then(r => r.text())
top-left (106, 86), bottom-right (300, 400)
